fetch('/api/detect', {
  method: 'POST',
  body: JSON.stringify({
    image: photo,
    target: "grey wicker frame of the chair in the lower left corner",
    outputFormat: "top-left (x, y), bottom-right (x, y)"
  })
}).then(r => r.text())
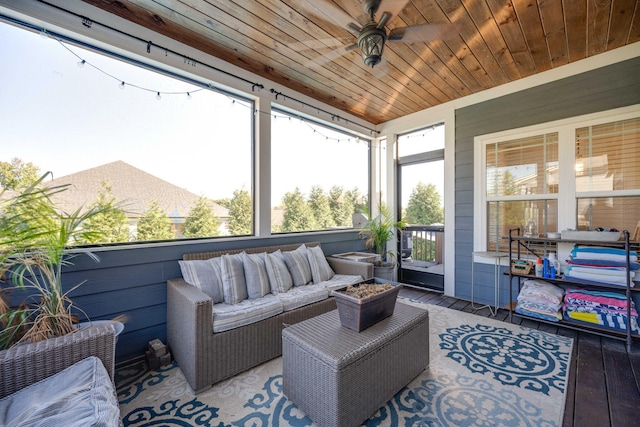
top-left (0, 325), bottom-right (116, 398)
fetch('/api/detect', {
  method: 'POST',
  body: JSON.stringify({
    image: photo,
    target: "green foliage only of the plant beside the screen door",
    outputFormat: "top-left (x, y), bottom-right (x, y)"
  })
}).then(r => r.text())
top-left (360, 203), bottom-right (407, 264)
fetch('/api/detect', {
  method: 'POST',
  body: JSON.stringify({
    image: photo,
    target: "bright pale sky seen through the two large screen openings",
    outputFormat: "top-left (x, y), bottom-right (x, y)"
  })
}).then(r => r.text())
top-left (0, 22), bottom-right (368, 205)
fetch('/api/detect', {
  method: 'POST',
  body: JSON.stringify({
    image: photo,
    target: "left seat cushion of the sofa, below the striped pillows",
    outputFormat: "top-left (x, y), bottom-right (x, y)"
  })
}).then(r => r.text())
top-left (213, 294), bottom-right (282, 334)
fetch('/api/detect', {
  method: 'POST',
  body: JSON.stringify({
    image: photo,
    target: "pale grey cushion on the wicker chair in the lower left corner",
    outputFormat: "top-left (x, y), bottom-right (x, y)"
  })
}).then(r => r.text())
top-left (0, 356), bottom-right (120, 427)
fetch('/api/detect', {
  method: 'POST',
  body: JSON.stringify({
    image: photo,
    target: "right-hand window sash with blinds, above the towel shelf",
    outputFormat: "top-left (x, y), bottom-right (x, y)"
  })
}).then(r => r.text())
top-left (575, 118), bottom-right (640, 234)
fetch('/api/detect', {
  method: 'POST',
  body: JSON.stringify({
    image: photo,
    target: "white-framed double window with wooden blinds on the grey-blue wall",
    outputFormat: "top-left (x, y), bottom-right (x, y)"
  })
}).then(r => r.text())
top-left (473, 104), bottom-right (640, 258)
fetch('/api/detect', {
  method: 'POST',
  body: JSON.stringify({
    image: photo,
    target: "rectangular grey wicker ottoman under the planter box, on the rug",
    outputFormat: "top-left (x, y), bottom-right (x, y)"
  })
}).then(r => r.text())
top-left (282, 302), bottom-right (429, 427)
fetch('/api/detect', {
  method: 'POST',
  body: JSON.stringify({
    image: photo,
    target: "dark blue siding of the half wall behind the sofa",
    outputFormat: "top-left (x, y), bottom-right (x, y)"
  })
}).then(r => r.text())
top-left (56, 231), bottom-right (364, 363)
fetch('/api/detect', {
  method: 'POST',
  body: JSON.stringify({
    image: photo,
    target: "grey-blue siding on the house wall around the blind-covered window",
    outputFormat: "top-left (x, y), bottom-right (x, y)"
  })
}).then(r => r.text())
top-left (455, 58), bottom-right (640, 306)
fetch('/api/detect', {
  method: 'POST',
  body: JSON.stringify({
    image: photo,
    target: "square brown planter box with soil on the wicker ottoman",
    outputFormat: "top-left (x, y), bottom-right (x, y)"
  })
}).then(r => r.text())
top-left (331, 285), bottom-right (402, 332)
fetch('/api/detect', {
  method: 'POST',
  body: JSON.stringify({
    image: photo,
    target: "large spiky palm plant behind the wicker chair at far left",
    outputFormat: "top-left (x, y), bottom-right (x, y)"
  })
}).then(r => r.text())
top-left (0, 173), bottom-right (120, 350)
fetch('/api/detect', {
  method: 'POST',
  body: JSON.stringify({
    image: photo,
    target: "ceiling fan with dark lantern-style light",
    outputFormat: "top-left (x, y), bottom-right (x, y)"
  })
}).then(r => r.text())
top-left (292, 0), bottom-right (453, 68)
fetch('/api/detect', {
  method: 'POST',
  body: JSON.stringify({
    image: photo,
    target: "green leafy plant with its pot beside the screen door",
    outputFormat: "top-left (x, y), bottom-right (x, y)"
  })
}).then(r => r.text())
top-left (360, 203), bottom-right (406, 280)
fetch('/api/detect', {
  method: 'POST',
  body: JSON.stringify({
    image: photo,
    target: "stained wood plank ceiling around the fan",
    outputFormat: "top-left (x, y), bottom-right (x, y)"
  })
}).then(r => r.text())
top-left (83, 0), bottom-right (640, 124)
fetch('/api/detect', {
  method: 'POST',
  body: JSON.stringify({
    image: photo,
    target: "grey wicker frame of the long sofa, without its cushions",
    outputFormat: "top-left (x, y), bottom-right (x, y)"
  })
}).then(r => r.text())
top-left (167, 242), bottom-right (373, 393)
